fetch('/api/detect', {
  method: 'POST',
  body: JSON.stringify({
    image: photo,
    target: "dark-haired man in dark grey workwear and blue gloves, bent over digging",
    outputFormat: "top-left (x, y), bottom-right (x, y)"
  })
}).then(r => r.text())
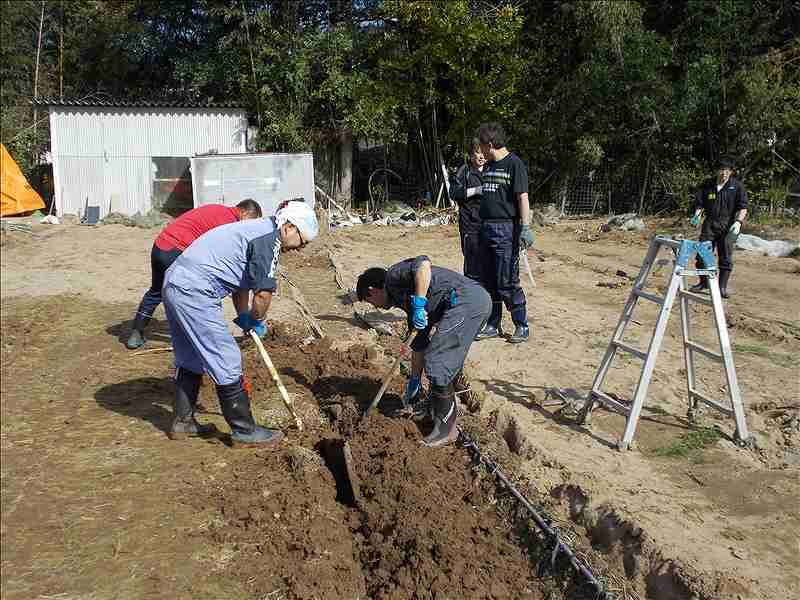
top-left (356, 256), bottom-right (492, 447)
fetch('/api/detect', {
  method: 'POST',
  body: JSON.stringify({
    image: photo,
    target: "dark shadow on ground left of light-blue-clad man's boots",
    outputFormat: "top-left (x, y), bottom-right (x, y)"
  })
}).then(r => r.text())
top-left (94, 377), bottom-right (175, 433)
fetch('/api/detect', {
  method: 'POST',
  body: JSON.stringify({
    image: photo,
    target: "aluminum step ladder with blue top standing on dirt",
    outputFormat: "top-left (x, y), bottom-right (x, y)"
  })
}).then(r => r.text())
top-left (578, 236), bottom-right (752, 450)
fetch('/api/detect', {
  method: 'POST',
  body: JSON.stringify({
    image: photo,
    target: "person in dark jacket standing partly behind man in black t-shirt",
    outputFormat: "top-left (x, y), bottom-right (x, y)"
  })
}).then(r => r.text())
top-left (450, 138), bottom-right (486, 282)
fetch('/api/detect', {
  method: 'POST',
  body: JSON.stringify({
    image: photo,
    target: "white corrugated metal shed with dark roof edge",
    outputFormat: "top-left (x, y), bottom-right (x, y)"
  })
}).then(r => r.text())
top-left (38, 100), bottom-right (247, 217)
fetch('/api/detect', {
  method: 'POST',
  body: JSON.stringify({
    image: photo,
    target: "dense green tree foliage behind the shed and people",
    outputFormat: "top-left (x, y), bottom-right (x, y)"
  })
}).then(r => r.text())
top-left (0, 0), bottom-right (800, 204)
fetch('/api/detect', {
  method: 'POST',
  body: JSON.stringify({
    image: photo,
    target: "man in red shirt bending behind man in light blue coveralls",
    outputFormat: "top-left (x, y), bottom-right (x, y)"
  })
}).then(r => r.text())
top-left (125, 199), bottom-right (261, 350)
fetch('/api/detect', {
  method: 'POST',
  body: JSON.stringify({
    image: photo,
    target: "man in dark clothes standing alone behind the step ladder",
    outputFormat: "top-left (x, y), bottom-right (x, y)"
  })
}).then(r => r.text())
top-left (691, 159), bottom-right (747, 298)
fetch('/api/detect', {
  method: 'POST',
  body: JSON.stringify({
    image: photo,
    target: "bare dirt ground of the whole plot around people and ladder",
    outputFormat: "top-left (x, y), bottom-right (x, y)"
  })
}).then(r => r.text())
top-left (0, 213), bottom-right (800, 600)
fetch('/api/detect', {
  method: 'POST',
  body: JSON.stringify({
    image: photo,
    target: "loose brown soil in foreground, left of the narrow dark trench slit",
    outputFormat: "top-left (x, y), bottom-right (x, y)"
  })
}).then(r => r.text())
top-left (195, 446), bottom-right (365, 598)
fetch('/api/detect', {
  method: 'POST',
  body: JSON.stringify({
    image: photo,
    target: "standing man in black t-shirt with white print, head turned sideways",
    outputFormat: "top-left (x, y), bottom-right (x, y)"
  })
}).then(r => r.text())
top-left (475, 123), bottom-right (533, 344)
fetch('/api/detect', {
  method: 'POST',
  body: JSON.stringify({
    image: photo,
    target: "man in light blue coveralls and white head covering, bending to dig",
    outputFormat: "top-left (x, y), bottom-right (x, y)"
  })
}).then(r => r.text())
top-left (162, 201), bottom-right (319, 445)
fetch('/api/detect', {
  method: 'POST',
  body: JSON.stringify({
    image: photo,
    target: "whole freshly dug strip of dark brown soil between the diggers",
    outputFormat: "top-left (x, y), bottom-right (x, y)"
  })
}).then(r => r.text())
top-left (187, 332), bottom-right (561, 599)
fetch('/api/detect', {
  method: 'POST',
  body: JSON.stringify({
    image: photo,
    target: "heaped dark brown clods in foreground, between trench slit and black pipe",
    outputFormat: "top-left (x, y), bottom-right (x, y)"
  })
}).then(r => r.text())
top-left (350, 415), bottom-right (542, 598)
